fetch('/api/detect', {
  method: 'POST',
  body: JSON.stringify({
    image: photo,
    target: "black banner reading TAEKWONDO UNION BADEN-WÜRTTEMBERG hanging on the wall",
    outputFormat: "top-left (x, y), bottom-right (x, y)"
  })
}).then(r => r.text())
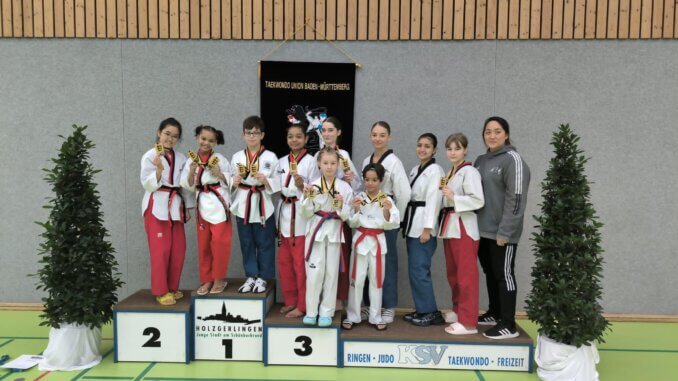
top-left (261, 61), bottom-right (356, 157)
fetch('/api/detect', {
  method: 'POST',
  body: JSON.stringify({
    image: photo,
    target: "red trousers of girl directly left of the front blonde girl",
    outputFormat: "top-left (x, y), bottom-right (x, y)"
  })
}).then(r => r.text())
top-left (278, 236), bottom-right (306, 312)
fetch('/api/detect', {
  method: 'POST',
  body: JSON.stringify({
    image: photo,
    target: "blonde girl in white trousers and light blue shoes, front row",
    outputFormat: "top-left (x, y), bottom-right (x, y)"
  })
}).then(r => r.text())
top-left (301, 146), bottom-right (353, 327)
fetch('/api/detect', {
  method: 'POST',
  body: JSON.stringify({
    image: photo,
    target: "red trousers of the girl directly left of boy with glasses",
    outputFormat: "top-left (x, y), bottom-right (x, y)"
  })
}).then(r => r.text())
top-left (196, 214), bottom-right (233, 283)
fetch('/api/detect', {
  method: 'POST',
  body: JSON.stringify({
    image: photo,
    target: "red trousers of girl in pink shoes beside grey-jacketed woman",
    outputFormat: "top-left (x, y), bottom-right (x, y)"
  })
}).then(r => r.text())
top-left (443, 219), bottom-right (478, 327)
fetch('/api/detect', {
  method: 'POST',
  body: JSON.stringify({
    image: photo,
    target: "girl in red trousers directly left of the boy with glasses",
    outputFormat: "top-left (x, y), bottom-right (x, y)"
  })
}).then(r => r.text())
top-left (181, 126), bottom-right (233, 295)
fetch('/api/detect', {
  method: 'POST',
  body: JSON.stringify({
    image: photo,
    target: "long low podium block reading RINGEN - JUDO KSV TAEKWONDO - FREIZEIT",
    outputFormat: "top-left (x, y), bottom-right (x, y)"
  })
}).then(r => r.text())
top-left (341, 315), bottom-right (534, 372)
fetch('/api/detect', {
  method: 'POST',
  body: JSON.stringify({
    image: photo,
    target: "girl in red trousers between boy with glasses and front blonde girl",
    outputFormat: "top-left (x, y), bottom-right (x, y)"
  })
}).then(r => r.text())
top-left (277, 123), bottom-right (318, 318)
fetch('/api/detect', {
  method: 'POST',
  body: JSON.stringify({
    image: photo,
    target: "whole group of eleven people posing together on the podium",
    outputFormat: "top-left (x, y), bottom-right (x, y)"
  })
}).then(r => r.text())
top-left (140, 116), bottom-right (530, 339)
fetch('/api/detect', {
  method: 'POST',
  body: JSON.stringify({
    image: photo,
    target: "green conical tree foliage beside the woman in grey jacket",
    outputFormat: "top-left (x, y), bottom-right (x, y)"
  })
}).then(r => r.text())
top-left (527, 125), bottom-right (609, 347)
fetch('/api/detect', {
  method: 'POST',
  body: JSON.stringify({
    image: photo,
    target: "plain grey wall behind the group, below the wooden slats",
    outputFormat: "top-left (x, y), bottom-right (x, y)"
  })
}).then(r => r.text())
top-left (0, 40), bottom-right (678, 314)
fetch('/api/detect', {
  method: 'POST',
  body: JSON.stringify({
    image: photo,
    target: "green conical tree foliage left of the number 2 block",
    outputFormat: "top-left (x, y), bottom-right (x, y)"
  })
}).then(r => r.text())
top-left (36, 125), bottom-right (122, 328)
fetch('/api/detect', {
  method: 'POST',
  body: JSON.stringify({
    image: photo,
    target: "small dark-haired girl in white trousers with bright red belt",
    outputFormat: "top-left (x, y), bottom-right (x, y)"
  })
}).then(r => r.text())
top-left (341, 164), bottom-right (400, 331)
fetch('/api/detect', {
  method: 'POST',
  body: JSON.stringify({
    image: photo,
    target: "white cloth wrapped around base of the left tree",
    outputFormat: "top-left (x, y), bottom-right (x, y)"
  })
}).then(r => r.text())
top-left (39, 324), bottom-right (101, 371)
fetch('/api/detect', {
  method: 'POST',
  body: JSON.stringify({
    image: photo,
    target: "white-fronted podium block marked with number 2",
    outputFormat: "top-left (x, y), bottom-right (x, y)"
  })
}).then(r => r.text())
top-left (113, 290), bottom-right (192, 363)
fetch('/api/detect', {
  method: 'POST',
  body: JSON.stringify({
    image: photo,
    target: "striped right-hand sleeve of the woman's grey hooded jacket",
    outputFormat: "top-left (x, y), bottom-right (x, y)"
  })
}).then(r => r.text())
top-left (497, 151), bottom-right (530, 241)
